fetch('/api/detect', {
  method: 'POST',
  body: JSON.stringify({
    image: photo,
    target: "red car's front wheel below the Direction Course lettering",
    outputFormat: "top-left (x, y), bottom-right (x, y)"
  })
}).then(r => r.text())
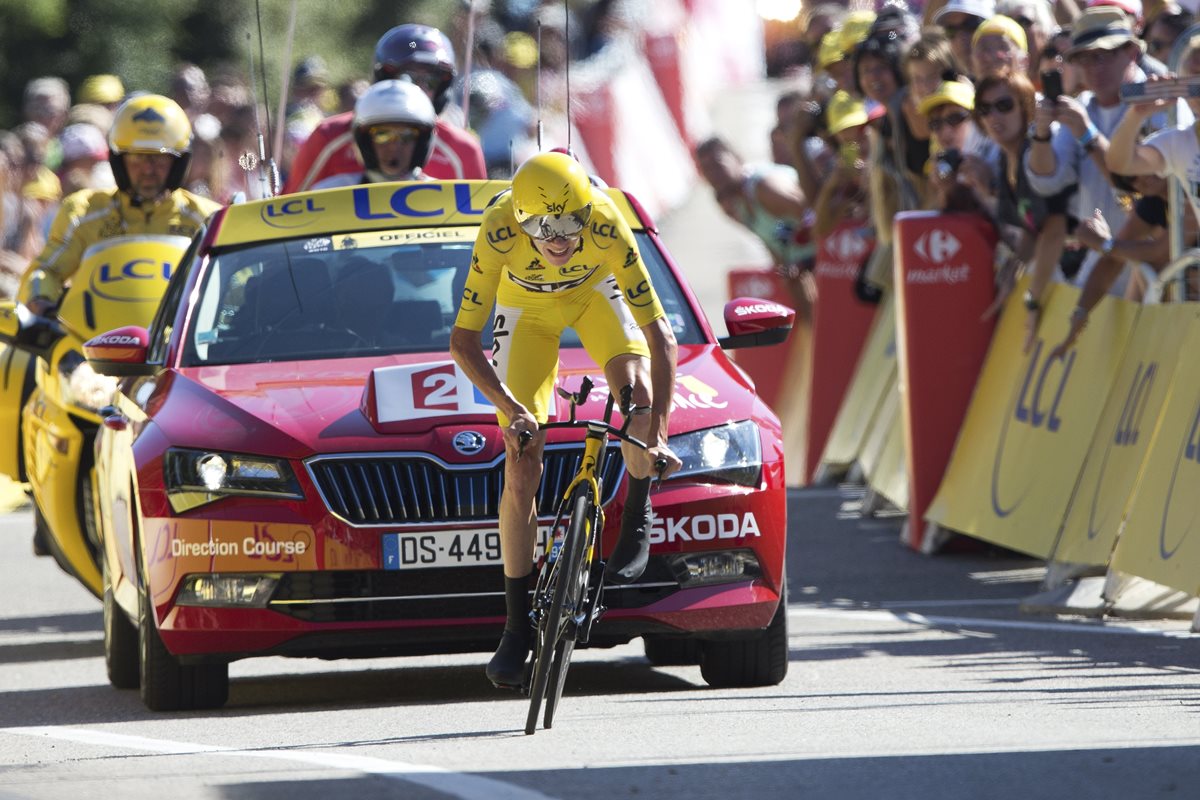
top-left (138, 585), bottom-right (229, 711)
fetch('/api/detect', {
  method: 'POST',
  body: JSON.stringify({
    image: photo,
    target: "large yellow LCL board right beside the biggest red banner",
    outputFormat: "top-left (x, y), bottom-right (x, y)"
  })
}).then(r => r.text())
top-left (925, 284), bottom-right (1140, 558)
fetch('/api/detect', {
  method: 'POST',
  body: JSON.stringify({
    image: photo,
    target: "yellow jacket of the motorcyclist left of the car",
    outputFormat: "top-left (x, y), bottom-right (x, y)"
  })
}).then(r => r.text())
top-left (18, 188), bottom-right (221, 302)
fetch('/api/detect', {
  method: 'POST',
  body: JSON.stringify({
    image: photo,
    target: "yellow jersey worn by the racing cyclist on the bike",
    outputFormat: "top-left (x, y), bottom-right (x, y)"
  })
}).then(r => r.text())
top-left (455, 192), bottom-right (665, 331)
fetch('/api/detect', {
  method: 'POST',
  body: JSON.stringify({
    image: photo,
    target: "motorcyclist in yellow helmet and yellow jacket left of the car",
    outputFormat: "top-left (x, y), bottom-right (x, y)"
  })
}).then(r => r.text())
top-left (18, 95), bottom-right (221, 314)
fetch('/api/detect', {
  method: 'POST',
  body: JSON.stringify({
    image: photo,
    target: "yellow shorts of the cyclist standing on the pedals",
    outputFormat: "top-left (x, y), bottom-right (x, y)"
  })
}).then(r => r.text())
top-left (492, 275), bottom-right (650, 426)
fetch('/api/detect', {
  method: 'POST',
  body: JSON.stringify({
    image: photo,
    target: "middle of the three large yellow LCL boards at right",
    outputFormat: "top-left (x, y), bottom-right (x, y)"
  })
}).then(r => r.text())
top-left (1054, 305), bottom-right (1198, 565)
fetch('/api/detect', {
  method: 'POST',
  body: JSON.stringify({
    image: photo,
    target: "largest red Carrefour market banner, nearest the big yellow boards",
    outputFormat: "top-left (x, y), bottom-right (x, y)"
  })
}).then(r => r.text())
top-left (894, 211), bottom-right (996, 551)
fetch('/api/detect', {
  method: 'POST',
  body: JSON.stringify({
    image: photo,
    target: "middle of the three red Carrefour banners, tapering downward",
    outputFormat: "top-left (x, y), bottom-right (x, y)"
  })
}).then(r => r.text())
top-left (804, 223), bottom-right (877, 481)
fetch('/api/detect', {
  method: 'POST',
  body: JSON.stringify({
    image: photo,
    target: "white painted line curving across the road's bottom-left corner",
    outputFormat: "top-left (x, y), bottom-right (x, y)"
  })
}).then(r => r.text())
top-left (0, 726), bottom-right (556, 800)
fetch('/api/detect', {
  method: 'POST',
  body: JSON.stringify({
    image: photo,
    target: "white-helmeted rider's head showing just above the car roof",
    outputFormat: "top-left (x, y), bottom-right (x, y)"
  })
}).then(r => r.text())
top-left (312, 79), bottom-right (437, 190)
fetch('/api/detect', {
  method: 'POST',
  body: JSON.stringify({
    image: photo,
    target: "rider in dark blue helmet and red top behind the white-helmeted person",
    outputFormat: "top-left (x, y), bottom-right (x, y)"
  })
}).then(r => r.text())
top-left (283, 24), bottom-right (487, 194)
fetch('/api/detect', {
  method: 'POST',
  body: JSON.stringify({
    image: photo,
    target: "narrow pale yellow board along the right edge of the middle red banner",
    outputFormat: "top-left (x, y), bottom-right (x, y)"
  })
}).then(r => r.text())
top-left (821, 291), bottom-right (896, 469)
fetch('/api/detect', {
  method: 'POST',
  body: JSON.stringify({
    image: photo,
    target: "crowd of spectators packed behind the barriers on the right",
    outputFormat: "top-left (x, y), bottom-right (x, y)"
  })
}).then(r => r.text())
top-left (695, 0), bottom-right (1200, 357)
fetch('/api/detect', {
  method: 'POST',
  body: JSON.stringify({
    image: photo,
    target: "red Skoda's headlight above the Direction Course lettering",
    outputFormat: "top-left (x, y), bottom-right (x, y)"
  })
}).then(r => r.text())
top-left (162, 447), bottom-right (304, 513)
